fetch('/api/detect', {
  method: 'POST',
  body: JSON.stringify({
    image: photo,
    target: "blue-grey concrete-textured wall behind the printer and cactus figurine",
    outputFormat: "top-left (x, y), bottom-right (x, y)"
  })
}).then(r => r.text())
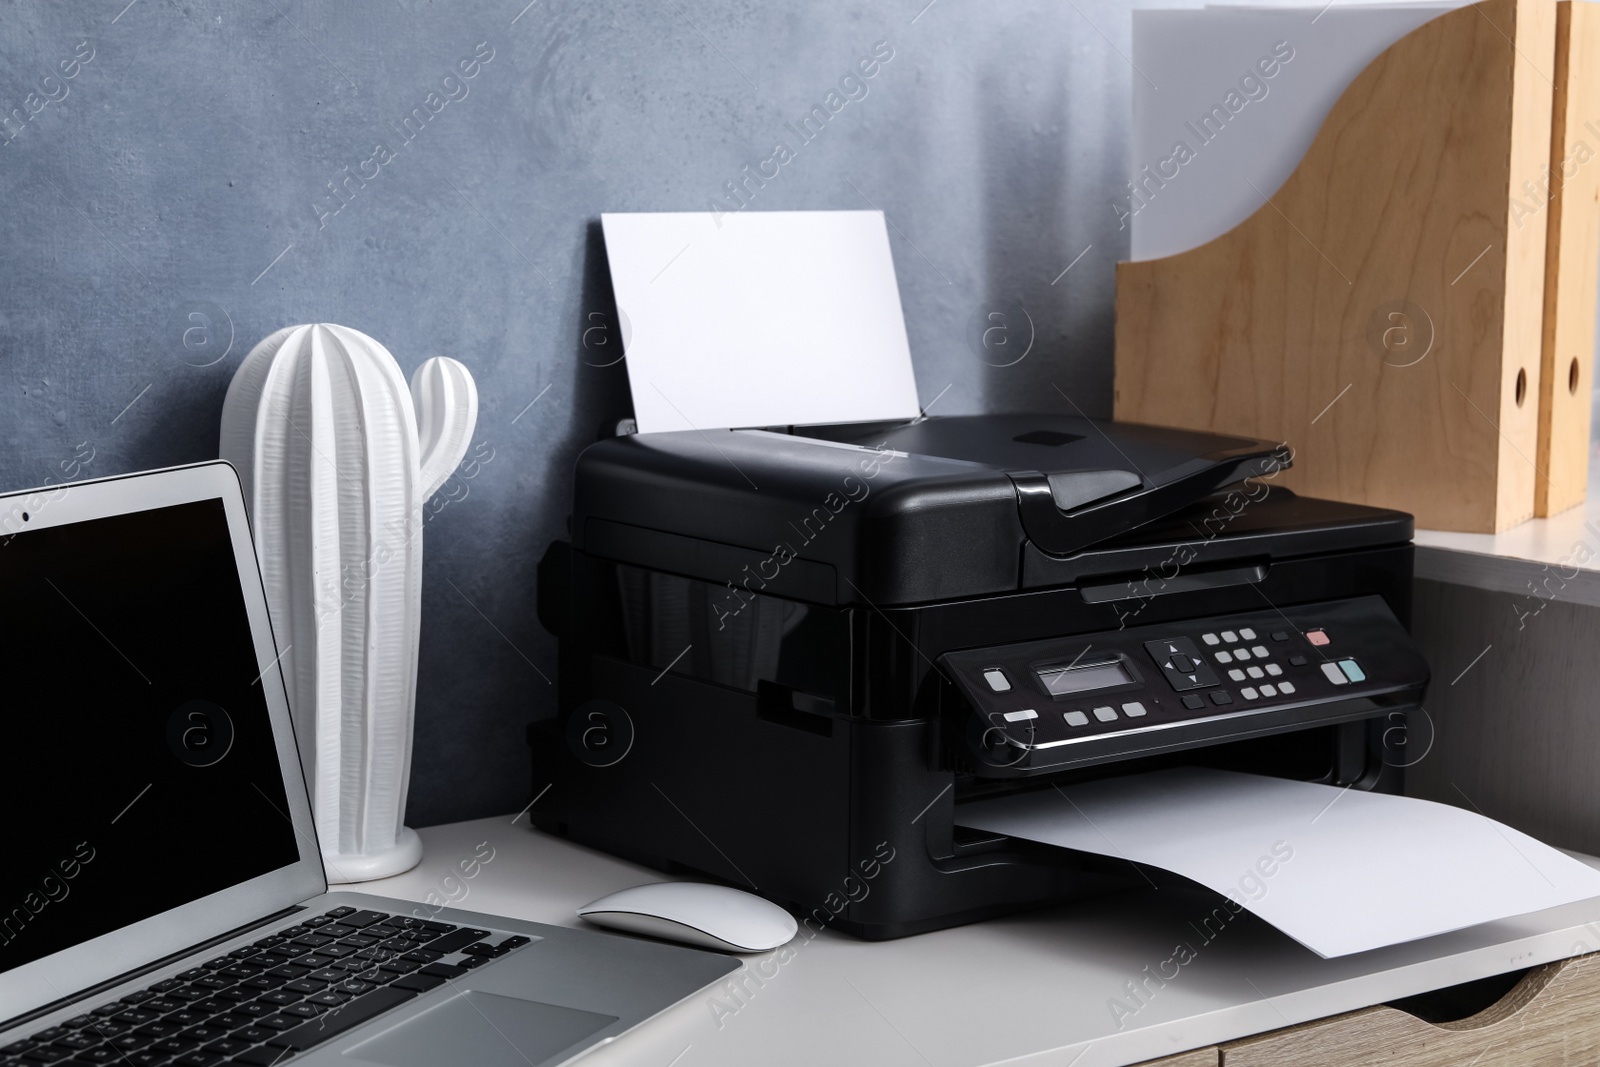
top-left (0, 0), bottom-right (1133, 825)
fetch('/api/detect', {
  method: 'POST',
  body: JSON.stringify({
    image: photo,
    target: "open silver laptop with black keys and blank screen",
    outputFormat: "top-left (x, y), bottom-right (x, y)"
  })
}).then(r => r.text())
top-left (0, 462), bottom-right (741, 1067)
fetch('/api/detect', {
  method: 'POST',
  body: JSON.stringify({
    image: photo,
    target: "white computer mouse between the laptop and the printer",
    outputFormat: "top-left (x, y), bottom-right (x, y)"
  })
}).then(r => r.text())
top-left (578, 881), bottom-right (798, 952)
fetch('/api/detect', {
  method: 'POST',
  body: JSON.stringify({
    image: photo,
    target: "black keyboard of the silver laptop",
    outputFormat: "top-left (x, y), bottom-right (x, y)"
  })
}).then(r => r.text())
top-left (0, 907), bottom-right (531, 1067)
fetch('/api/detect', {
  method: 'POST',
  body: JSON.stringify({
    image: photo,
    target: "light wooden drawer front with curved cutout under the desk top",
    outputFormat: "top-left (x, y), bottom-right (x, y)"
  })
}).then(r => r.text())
top-left (1209, 953), bottom-right (1600, 1067)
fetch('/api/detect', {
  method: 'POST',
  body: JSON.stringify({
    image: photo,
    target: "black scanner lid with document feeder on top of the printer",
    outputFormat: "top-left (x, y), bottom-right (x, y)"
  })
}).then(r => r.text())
top-left (571, 414), bottom-right (1411, 605)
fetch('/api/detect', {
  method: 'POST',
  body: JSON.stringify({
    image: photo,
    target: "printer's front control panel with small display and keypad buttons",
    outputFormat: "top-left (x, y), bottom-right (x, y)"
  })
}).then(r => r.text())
top-left (941, 597), bottom-right (1429, 776)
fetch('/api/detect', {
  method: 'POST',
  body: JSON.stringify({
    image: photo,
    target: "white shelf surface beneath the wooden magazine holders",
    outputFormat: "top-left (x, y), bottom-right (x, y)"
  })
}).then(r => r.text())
top-left (1414, 462), bottom-right (1600, 609)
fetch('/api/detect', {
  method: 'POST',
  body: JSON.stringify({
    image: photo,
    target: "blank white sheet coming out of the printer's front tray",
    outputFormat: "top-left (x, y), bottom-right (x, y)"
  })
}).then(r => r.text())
top-left (955, 768), bottom-right (1600, 957)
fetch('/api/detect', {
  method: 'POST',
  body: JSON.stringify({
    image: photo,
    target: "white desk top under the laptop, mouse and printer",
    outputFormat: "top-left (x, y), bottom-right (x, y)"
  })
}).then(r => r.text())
top-left (349, 816), bottom-right (1600, 1067)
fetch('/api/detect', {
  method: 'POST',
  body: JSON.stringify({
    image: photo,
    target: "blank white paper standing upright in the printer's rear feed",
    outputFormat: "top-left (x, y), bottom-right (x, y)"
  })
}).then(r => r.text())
top-left (600, 211), bottom-right (918, 434)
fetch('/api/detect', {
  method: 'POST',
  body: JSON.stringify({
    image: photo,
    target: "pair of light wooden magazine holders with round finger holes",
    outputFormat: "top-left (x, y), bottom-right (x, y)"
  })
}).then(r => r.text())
top-left (1115, 0), bottom-right (1600, 531)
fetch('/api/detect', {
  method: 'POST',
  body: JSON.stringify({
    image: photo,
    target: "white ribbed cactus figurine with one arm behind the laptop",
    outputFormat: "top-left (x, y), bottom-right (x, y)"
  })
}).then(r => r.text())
top-left (221, 323), bottom-right (478, 881)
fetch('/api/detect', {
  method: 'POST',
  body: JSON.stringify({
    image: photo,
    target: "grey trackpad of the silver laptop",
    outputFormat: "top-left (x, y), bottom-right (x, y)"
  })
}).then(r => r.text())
top-left (344, 990), bottom-right (616, 1067)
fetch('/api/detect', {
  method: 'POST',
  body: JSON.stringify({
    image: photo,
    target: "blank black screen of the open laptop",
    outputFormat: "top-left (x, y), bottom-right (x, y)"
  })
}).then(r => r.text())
top-left (0, 499), bottom-right (300, 971)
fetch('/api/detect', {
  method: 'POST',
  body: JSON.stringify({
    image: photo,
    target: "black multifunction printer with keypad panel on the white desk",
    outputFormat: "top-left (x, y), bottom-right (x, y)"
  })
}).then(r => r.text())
top-left (528, 414), bottom-right (1429, 939)
